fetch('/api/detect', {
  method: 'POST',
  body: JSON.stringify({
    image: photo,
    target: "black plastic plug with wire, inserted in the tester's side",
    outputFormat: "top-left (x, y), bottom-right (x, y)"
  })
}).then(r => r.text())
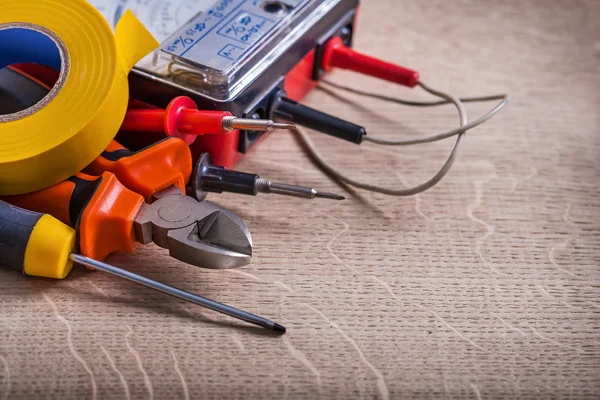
top-left (273, 97), bottom-right (367, 144)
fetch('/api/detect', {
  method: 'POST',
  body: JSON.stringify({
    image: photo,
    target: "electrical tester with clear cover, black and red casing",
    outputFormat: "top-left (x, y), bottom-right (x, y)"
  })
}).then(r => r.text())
top-left (91, 0), bottom-right (358, 168)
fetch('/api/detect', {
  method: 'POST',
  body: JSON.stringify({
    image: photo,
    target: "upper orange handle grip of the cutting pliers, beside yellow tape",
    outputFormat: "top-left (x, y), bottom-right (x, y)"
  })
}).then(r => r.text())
top-left (84, 138), bottom-right (192, 203)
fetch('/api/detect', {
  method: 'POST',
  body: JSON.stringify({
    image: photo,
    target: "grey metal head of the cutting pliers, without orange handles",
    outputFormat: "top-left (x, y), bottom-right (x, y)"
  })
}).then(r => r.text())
top-left (134, 188), bottom-right (252, 269)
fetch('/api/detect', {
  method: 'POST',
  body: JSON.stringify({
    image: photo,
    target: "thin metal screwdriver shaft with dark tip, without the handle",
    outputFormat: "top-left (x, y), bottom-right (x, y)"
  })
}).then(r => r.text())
top-left (69, 253), bottom-right (286, 333)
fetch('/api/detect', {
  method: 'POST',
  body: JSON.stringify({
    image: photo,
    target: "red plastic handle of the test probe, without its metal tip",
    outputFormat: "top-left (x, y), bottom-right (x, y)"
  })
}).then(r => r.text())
top-left (121, 96), bottom-right (232, 145)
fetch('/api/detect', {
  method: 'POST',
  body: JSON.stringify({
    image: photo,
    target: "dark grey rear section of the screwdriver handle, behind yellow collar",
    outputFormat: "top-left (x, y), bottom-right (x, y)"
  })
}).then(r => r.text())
top-left (0, 201), bottom-right (43, 272)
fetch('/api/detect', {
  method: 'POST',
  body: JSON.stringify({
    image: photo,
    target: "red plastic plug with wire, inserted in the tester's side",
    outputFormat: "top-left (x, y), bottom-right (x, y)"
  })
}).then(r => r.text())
top-left (321, 37), bottom-right (419, 87)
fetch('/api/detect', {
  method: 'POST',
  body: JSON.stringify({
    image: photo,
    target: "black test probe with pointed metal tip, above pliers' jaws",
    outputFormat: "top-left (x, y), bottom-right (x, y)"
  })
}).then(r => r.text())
top-left (188, 153), bottom-right (346, 201)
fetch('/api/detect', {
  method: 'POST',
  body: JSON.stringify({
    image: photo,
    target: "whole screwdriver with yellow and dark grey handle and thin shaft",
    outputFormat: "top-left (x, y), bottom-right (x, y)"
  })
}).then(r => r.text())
top-left (0, 201), bottom-right (286, 333)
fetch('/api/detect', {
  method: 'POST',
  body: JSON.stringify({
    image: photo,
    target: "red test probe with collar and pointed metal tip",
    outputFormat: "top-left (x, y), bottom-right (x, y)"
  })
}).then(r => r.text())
top-left (121, 96), bottom-right (295, 145)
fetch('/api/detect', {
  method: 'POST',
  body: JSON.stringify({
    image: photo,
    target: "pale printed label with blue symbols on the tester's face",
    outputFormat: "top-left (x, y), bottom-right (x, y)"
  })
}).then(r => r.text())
top-left (161, 0), bottom-right (285, 70)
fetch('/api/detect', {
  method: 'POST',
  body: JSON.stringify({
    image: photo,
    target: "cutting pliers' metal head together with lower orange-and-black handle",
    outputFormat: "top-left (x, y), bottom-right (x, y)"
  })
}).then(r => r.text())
top-left (4, 172), bottom-right (252, 269)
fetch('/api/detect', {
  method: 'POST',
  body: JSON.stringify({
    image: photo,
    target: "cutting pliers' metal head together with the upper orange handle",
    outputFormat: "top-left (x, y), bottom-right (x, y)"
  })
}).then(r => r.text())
top-left (85, 138), bottom-right (252, 269)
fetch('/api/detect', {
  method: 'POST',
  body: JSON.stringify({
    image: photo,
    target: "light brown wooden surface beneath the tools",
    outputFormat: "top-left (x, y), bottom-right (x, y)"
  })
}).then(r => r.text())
top-left (0, 0), bottom-right (600, 400)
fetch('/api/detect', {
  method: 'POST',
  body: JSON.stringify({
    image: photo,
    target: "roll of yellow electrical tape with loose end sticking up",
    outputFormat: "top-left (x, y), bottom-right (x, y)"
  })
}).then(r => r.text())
top-left (0, 0), bottom-right (158, 195)
